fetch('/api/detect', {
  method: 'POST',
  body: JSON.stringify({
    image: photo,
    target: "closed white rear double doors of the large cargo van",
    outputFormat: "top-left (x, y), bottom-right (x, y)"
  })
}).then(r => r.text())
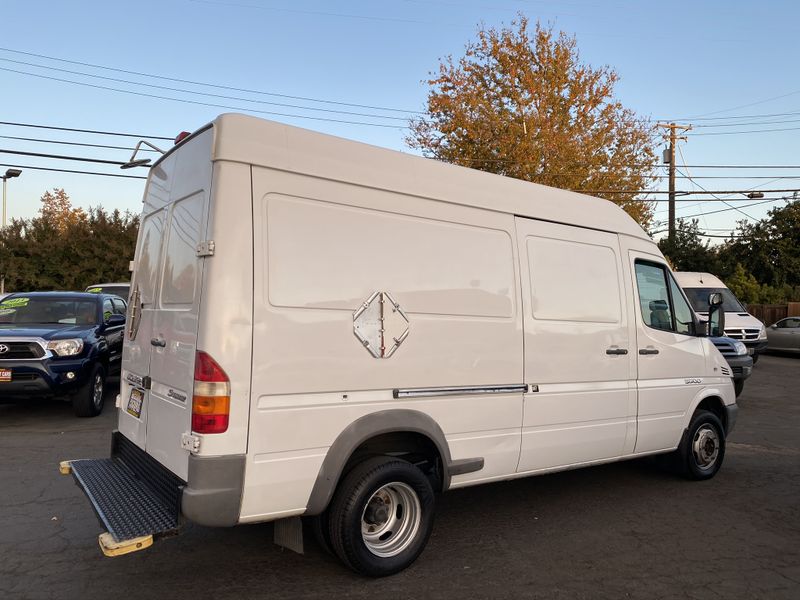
top-left (119, 129), bottom-right (212, 480)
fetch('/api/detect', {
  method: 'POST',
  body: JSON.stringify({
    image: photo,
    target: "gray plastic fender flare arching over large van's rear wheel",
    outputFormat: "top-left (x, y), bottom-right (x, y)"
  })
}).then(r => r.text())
top-left (305, 409), bottom-right (483, 515)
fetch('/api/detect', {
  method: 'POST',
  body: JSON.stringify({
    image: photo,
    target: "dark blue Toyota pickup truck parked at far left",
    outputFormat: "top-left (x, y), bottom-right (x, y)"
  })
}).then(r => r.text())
top-left (0, 292), bottom-right (126, 417)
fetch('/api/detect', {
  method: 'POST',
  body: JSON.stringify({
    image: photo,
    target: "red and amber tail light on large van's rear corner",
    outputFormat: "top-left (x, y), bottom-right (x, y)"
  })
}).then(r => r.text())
top-left (192, 350), bottom-right (231, 433)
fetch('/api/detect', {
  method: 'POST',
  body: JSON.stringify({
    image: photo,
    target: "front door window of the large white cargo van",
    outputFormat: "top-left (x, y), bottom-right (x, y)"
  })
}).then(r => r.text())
top-left (636, 260), bottom-right (694, 335)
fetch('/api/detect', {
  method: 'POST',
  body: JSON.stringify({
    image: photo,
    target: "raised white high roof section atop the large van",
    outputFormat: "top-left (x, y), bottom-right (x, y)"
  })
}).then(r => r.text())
top-left (161, 114), bottom-right (650, 241)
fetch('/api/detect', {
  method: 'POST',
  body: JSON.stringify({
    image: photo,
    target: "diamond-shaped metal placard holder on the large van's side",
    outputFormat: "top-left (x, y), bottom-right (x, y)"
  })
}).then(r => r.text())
top-left (353, 292), bottom-right (408, 358)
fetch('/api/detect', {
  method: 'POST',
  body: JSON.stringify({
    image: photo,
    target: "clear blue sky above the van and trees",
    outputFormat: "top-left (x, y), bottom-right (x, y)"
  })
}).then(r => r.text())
top-left (0, 0), bottom-right (800, 239)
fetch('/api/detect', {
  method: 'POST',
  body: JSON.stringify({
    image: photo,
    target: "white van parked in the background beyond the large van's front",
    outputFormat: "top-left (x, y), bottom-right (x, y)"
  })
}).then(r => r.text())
top-left (675, 271), bottom-right (767, 364)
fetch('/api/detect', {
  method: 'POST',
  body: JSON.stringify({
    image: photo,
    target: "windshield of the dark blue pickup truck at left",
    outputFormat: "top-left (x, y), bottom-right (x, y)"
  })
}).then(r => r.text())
top-left (0, 296), bottom-right (97, 325)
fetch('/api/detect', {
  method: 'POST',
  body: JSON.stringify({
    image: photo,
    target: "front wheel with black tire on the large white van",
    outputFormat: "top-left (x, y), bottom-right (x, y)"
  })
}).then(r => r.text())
top-left (676, 410), bottom-right (725, 481)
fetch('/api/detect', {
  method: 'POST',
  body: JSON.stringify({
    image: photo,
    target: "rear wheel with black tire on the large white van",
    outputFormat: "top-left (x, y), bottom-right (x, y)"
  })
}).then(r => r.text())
top-left (328, 456), bottom-right (435, 577)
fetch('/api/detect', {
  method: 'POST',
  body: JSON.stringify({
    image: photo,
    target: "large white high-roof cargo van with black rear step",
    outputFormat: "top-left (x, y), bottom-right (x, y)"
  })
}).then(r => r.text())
top-left (62, 114), bottom-right (737, 576)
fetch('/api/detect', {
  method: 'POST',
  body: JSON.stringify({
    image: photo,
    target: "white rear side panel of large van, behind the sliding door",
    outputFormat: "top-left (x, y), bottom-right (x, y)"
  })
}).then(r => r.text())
top-left (241, 167), bottom-right (523, 521)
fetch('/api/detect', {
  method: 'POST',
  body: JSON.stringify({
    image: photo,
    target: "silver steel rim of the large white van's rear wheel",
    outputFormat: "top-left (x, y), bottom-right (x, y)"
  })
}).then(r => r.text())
top-left (361, 482), bottom-right (422, 558)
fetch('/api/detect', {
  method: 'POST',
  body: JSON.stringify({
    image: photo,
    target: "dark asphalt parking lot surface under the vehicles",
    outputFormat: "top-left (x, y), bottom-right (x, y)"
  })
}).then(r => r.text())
top-left (0, 356), bottom-right (800, 600)
